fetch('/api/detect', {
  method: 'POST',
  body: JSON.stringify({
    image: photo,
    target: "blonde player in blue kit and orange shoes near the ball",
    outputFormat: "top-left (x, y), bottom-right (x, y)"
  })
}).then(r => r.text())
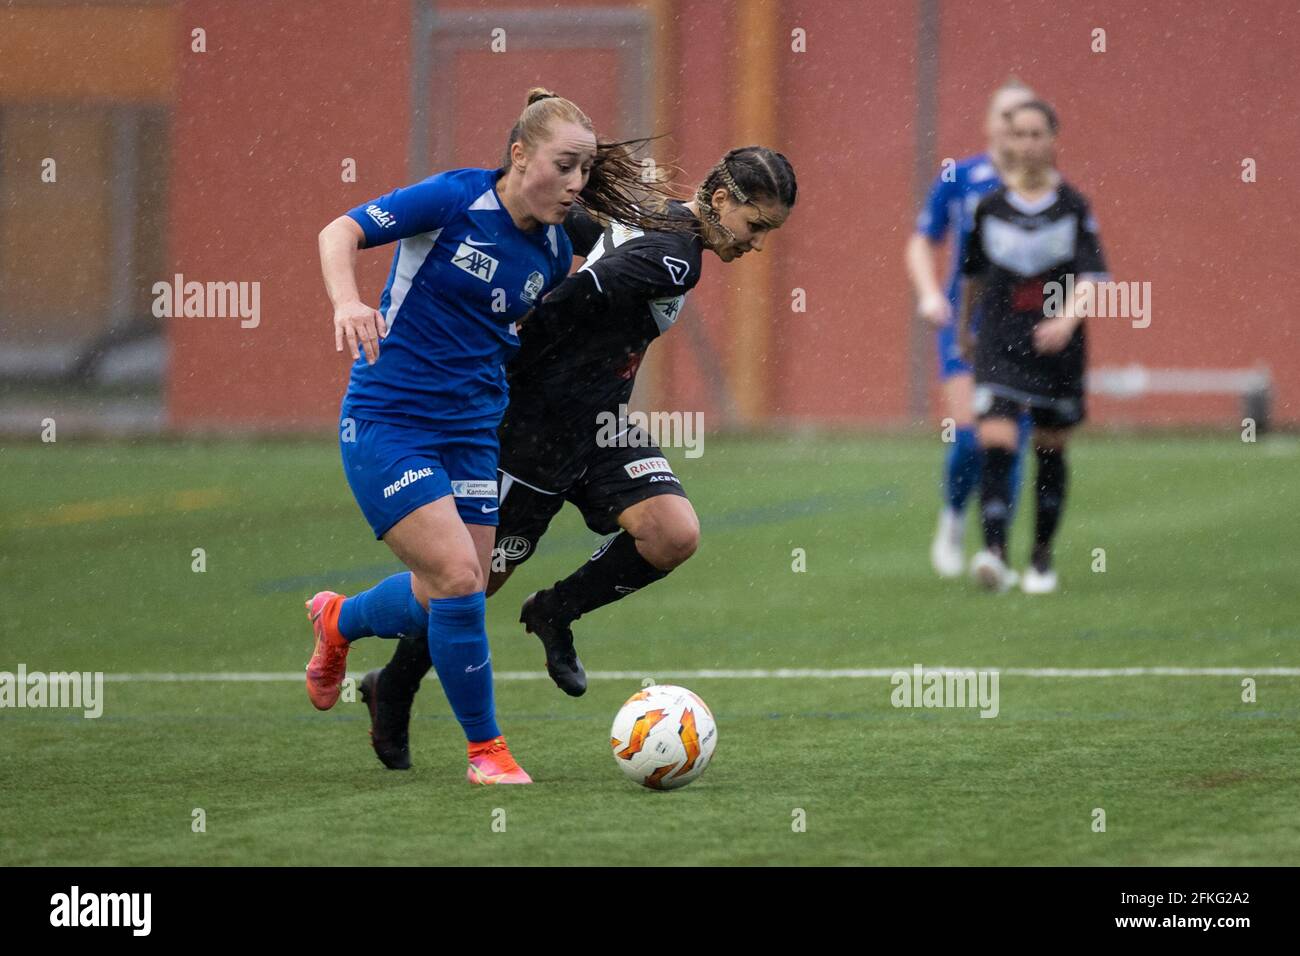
top-left (307, 90), bottom-right (686, 783)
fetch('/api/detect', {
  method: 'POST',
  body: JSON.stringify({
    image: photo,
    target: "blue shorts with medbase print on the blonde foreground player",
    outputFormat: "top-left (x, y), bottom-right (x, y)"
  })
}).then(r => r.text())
top-left (338, 418), bottom-right (498, 538)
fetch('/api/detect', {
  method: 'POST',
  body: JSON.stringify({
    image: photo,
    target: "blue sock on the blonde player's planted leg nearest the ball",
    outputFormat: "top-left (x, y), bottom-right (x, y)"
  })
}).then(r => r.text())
top-left (429, 591), bottom-right (501, 743)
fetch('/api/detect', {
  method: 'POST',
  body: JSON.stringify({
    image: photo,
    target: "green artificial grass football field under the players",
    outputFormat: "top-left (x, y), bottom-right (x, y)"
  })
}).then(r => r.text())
top-left (0, 432), bottom-right (1300, 865)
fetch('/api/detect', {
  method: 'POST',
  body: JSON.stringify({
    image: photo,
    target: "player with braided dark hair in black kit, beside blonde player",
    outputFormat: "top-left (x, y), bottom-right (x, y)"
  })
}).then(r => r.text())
top-left (361, 146), bottom-right (796, 769)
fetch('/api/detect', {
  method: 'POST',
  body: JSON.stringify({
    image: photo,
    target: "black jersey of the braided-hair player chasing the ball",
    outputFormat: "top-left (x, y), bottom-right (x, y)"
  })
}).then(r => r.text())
top-left (501, 202), bottom-right (703, 492)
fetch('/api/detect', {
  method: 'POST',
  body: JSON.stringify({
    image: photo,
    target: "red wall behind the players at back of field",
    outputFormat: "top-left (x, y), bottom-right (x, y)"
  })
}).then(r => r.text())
top-left (168, 0), bottom-right (1300, 428)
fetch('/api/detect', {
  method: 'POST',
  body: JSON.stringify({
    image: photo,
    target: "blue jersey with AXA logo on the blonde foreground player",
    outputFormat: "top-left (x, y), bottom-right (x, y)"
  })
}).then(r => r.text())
top-left (342, 169), bottom-right (573, 432)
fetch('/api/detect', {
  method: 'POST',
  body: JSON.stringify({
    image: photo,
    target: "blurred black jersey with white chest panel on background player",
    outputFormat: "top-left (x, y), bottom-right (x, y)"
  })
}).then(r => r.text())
top-left (962, 182), bottom-right (1106, 397)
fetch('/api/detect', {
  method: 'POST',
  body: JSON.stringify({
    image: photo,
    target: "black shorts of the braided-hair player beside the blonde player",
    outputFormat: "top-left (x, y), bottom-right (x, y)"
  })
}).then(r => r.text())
top-left (494, 445), bottom-right (686, 566)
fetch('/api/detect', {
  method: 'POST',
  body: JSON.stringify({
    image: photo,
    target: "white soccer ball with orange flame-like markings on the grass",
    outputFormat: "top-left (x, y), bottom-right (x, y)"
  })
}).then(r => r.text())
top-left (610, 684), bottom-right (718, 790)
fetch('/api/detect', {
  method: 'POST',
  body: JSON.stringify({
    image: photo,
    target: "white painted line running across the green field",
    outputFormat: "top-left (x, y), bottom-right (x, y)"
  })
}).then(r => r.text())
top-left (96, 665), bottom-right (1300, 684)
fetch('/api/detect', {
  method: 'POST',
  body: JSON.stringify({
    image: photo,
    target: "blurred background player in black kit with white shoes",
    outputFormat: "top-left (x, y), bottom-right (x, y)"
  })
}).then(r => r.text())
top-left (961, 100), bottom-right (1106, 594)
